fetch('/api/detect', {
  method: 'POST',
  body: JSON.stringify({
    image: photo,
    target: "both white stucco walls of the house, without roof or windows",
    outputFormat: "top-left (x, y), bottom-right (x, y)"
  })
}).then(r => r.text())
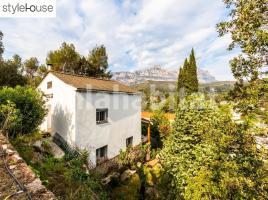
top-left (38, 74), bottom-right (141, 164)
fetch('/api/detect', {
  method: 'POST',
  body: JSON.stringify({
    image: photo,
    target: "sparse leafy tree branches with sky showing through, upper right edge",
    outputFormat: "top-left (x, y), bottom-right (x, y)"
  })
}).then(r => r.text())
top-left (217, 0), bottom-right (268, 118)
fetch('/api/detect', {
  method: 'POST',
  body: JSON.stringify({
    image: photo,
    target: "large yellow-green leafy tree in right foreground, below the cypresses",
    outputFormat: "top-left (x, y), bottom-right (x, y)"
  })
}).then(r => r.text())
top-left (160, 96), bottom-right (268, 199)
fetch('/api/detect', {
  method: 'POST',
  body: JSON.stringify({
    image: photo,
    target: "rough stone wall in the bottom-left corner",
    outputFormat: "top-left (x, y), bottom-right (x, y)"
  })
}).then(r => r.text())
top-left (0, 133), bottom-right (56, 200)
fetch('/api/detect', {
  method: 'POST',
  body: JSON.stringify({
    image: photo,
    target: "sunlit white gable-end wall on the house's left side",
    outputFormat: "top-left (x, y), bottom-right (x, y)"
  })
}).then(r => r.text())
top-left (38, 74), bottom-right (76, 145)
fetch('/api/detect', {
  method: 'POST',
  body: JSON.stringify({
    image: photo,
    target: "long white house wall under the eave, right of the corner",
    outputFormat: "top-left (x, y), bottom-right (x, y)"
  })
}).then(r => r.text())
top-left (75, 92), bottom-right (141, 164)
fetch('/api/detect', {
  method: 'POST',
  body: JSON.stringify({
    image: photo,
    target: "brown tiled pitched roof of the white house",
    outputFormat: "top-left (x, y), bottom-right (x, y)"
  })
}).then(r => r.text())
top-left (50, 71), bottom-right (138, 93)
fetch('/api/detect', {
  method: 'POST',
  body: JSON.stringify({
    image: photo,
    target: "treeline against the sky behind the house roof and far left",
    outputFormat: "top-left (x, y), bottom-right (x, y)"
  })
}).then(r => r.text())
top-left (0, 31), bottom-right (111, 87)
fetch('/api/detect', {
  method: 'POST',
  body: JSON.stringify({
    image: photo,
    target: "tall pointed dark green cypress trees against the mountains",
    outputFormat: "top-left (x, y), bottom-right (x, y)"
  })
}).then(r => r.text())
top-left (177, 49), bottom-right (198, 98)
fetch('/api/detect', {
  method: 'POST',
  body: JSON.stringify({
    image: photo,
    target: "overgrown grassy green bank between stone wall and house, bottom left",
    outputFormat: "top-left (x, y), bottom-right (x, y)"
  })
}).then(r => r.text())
top-left (33, 151), bottom-right (109, 200)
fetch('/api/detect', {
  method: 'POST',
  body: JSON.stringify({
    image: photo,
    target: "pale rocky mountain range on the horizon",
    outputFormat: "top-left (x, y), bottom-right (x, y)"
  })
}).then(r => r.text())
top-left (112, 66), bottom-right (217, 85)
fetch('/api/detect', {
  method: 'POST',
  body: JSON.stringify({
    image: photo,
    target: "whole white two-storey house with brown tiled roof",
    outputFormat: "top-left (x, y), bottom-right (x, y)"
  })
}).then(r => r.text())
top-left (38, 71), bottom-right (141, 165)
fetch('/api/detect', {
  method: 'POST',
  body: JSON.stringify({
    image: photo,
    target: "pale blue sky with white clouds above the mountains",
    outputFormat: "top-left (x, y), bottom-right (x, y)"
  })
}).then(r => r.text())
top-left (0, 0), bottom-right (238, 80)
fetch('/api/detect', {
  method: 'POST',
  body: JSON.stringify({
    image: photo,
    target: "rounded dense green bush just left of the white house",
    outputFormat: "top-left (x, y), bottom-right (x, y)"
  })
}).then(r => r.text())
top-left (0, 86), bottom-right (46, 136)
